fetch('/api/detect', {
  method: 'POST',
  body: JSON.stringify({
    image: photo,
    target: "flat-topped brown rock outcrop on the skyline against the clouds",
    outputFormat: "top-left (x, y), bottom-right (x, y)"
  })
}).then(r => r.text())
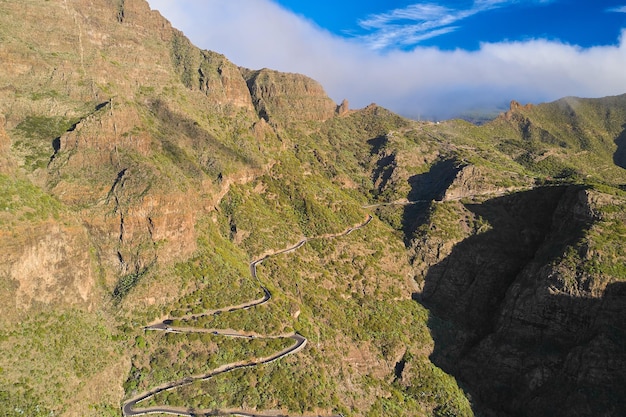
top-left (242, 69), bottom-right (337, 122)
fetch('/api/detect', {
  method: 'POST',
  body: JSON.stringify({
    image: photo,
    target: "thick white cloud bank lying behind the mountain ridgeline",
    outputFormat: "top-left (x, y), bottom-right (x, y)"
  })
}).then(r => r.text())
top-left (149, 0), bottom-right (626, 119)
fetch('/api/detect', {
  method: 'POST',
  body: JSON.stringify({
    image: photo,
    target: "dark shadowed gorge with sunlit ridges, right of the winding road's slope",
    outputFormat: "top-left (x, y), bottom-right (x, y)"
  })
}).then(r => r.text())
top-left (356, 96), bottom-right (626, 416)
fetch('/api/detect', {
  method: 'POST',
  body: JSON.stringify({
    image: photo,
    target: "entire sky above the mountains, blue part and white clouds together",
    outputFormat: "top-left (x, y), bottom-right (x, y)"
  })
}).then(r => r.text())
top-left (148, 0), bottom-right (626, 119)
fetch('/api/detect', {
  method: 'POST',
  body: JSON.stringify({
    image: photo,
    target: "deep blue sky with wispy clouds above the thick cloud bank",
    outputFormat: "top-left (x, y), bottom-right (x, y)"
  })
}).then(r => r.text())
top-left (277, 0), bottom-right (626, 50)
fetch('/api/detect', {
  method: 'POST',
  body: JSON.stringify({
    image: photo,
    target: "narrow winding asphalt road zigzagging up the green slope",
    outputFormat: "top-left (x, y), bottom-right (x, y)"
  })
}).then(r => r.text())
top-left (122, 215), bottom-right (372, 417)
